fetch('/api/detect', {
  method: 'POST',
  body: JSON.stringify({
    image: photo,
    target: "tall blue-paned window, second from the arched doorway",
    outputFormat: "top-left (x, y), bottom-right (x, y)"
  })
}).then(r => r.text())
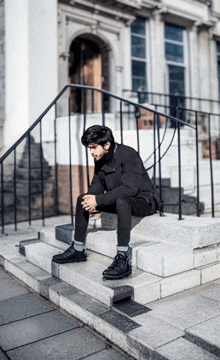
top-left (164, 24), bottom-right (185, 122)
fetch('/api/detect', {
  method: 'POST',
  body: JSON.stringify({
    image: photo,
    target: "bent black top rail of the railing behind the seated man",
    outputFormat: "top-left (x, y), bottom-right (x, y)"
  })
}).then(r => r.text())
top-left (0, 84), bottom-right (195, 163)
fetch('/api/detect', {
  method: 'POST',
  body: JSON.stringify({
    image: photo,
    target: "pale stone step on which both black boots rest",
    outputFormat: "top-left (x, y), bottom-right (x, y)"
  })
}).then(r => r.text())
top-left (21, 240), bottom-right (161, 306)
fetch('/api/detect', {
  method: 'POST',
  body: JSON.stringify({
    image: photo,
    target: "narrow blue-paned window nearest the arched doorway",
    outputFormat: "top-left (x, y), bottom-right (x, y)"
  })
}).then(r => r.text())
top-left (131, 19), bottom-right (147, 91)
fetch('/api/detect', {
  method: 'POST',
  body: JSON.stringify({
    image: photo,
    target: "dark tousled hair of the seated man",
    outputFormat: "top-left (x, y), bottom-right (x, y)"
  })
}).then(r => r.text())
top-left (81, 125), bottom-right (115, 147)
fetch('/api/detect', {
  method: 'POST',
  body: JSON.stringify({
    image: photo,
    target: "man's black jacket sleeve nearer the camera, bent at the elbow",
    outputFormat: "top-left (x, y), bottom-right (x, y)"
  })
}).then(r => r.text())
top-left (96, 148), bottom-right (143, 206)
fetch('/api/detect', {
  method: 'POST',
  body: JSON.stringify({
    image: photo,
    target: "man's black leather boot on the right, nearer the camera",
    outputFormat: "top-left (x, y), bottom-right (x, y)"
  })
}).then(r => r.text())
top-left (102, 253), bottom-right (132, 280)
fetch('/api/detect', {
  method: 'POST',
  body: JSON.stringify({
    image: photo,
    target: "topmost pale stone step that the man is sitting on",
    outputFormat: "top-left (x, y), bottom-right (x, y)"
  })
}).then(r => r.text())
top-left (101, 213), bottom-right (220, 249)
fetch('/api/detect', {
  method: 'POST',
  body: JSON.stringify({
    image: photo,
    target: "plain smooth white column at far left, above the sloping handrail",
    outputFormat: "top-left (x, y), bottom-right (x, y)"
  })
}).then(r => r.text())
top-left (3, 0), bottom-right (58, 150)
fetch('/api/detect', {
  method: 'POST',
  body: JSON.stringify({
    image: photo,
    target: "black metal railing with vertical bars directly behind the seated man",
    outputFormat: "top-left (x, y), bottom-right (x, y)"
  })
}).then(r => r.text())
top-left (0, 84), bottom-right (204, 233)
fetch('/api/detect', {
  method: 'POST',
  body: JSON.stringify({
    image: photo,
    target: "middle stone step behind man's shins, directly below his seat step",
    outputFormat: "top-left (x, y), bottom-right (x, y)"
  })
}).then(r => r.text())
top-left (40, 226), bottom-right (193, 277)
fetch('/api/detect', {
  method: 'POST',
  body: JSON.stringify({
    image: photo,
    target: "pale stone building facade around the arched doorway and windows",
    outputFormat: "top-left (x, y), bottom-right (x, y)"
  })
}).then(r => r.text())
top-left (3, 0), bottom-right (220, 158)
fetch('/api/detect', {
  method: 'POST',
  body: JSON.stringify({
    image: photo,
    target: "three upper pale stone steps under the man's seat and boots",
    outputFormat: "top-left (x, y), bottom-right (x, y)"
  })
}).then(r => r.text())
top-left (16, 214), bottom-right (220, 306)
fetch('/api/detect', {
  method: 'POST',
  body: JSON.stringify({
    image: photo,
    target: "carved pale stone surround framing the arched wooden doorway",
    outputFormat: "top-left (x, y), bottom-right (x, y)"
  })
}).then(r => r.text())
top-left (58, 3), bottom-right (135, 95)
